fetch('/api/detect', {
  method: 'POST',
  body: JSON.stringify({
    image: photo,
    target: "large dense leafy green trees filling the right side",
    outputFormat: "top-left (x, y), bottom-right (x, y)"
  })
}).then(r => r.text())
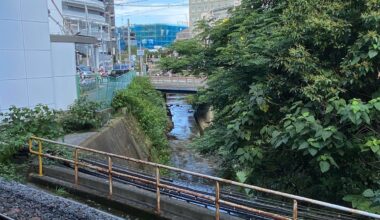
top-left (190, 0), bottom-right (380, 212)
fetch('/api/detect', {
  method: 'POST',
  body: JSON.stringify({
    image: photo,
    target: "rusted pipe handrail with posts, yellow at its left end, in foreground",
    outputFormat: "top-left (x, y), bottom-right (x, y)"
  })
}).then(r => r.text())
top-left (29, 137), bottom-right (380, 220)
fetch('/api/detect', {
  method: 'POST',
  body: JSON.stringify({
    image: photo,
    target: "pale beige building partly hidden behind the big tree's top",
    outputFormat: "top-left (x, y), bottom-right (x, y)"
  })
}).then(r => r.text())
top-left (189, 0), bottom-right (241, 34)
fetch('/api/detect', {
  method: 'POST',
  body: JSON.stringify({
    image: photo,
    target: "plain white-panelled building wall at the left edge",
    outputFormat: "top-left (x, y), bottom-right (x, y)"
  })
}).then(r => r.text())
top-left (0, 0), bottom-right (77, 111)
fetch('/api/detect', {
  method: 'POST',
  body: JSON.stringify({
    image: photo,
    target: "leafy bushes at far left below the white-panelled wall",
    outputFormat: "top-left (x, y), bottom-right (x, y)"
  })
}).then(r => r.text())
top-left (0, 105), bottom-right (63, 162)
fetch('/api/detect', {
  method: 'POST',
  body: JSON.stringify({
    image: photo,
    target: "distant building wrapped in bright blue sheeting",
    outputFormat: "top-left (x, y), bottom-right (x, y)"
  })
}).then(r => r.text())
top-left (117, 24), bottom-right (187, 49)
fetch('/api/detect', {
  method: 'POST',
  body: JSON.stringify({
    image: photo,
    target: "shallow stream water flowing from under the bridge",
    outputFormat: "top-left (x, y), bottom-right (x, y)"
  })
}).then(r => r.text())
top-left (166, 93), bottom-right (218, 180)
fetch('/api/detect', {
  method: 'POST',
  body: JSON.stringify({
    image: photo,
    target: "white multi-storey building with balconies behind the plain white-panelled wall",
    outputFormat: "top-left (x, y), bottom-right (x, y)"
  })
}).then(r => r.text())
top-left (49, 0), bottom-right (117, 67)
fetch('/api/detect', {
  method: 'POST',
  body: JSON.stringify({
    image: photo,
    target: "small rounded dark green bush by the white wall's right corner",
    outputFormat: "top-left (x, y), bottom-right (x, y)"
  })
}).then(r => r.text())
top-left (61, 97), bottom-right (101, 132)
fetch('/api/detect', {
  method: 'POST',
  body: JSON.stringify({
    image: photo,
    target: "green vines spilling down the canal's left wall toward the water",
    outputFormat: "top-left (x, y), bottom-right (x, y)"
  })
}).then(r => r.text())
top-left (112, 77), bottom-right (170, 163)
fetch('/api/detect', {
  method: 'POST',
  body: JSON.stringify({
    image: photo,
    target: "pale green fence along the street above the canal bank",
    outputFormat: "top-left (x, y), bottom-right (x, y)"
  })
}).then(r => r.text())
top-left (77, 71), bottom-right (136, 108)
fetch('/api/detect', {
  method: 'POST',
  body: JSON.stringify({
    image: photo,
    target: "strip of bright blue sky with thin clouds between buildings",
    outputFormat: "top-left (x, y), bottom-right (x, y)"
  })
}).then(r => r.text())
top-left (115, 0), bottom-right (189, 27)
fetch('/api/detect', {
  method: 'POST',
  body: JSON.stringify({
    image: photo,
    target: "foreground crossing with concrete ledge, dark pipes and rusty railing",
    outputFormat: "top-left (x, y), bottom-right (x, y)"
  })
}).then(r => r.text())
top-left (29, 137), bottom-right (380, 220)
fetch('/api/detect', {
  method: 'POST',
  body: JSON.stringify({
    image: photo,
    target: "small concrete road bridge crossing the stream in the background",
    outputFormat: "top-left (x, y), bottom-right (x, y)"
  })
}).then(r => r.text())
top-left (149, 76), bottom-right (207, 93)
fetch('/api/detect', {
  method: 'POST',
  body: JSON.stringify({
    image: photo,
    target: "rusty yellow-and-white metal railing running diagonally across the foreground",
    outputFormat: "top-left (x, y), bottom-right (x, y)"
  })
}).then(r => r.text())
top-left (29, 137), bottom-right (380, 220)
